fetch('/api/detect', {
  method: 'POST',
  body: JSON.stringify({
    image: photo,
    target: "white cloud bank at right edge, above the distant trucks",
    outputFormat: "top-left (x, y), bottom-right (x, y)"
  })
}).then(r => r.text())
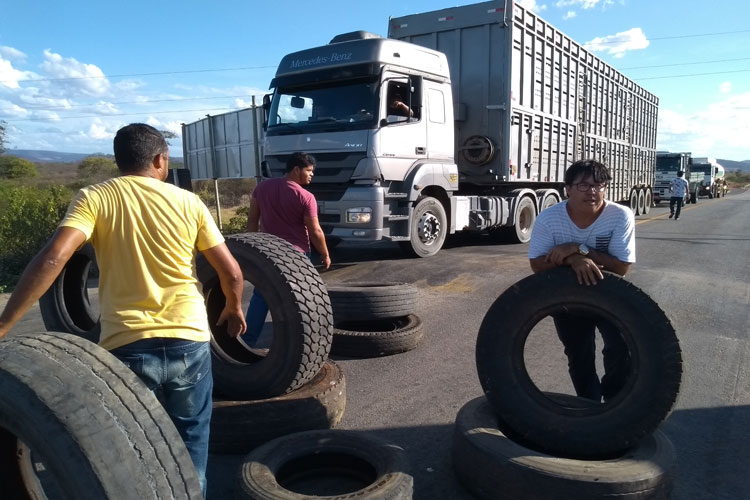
top-left (657, 92), bottom-right (750, 161)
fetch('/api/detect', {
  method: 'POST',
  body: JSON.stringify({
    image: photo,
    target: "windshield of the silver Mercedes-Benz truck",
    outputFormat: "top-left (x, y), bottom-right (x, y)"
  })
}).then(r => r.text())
top-left (266, 80), bottom-right (378, 135)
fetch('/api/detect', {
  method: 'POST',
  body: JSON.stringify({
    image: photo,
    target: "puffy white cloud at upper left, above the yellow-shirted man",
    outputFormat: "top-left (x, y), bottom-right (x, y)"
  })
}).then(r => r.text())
top-left (41, 49), bottom-right (110, 97)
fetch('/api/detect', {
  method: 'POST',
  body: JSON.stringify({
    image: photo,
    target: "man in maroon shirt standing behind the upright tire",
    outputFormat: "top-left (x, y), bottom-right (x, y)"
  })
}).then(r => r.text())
top-left (242, 153), bottom-right (331, 345)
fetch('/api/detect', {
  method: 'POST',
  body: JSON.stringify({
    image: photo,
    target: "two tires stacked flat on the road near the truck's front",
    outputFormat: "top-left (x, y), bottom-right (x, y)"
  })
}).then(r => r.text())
top-left (327, 282), bottom-right (424, 358)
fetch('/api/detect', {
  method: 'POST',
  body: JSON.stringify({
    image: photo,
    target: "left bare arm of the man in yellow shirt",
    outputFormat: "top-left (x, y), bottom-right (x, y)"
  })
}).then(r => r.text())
top-left (0, 226), bottom-right (86, 338)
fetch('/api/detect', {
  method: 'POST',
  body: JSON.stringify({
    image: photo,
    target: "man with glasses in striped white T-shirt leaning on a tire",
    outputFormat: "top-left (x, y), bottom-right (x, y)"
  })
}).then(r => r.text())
top-left (529, 160), bottom-right (635, 402)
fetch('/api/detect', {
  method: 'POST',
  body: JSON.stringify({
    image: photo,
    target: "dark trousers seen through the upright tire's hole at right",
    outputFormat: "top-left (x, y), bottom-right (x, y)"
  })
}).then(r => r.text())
top-left (553, 313), bottom-right (630, 401)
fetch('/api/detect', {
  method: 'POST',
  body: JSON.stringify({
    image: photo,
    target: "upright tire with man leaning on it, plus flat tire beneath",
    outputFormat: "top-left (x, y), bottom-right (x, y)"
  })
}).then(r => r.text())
top-left (453, 268), bottom-right (682, 500)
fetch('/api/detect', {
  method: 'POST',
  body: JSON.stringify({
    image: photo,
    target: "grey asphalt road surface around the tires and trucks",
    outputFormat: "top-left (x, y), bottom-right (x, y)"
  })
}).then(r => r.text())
top-left (0, 190), bottom-right (750, 500)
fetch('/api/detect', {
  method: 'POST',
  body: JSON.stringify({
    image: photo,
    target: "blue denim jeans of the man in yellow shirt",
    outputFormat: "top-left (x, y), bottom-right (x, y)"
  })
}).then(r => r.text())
top-left (111, 338), bottom-right (214, 497)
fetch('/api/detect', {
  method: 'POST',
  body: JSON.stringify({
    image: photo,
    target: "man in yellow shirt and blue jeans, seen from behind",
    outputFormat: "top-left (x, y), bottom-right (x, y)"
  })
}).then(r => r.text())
top-left (0, 123), bottom-right (246, 494)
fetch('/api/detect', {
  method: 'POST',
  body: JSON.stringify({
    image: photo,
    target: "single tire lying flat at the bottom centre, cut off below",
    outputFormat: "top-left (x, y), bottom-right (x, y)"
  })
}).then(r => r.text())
top-left (239, 430), bottom-right (414, 500)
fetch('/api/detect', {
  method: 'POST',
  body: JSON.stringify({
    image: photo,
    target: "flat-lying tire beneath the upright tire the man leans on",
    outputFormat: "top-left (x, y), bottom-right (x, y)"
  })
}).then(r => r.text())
top-left (452, 396), bottom-right (677, 500)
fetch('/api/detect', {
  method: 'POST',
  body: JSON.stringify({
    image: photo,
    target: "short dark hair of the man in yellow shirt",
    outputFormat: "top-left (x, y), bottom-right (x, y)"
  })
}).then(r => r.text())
top-left (114, 123), bottom-right (169, 173)
